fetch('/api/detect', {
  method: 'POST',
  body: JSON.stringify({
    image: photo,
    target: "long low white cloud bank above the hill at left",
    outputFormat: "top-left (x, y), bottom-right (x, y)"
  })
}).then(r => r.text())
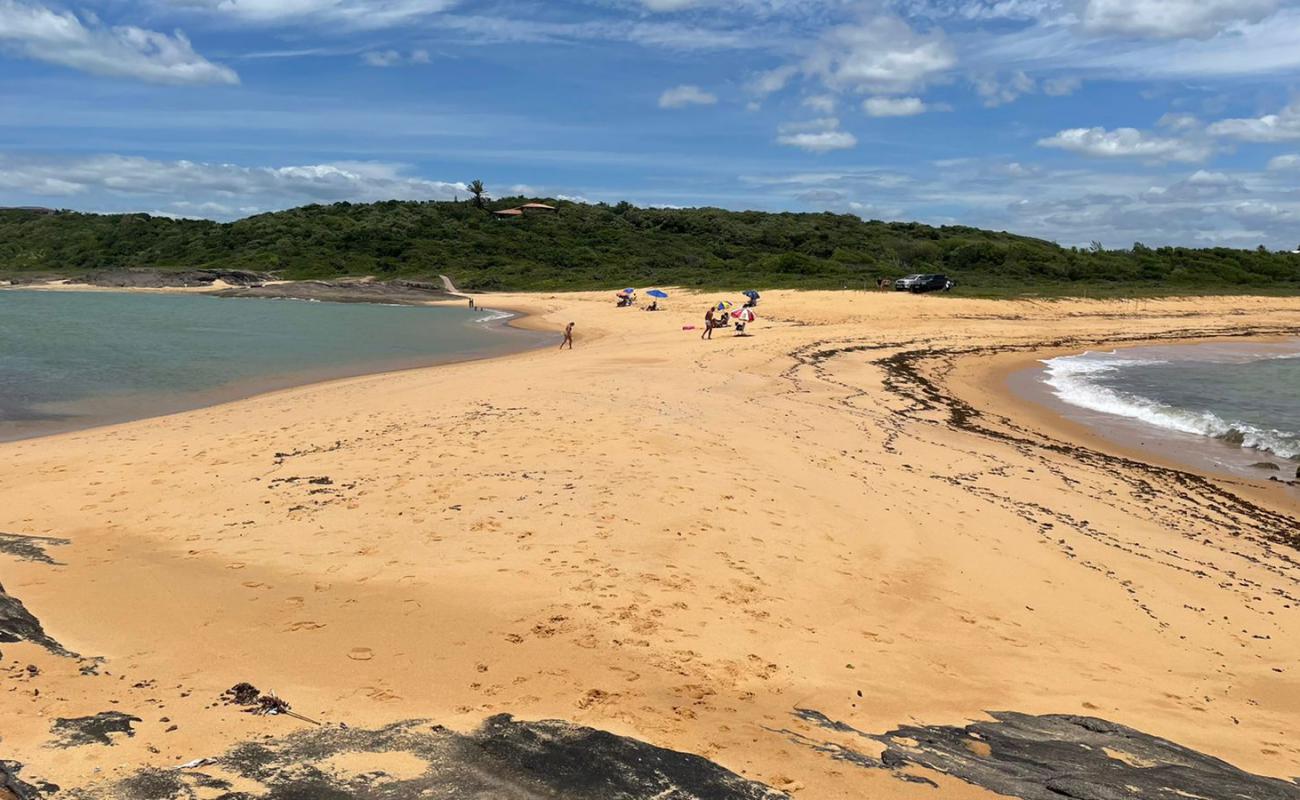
top-left (0, 155), bottom-right (465, 216)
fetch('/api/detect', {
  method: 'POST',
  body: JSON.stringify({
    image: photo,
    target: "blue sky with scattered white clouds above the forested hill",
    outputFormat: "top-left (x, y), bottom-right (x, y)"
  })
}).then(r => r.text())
top-left (0, 0), bottom-right (1300, 250)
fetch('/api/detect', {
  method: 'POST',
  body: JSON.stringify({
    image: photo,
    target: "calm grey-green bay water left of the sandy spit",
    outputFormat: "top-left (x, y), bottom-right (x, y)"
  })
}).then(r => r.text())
top-left (0, 290), bottom-right (541, 440)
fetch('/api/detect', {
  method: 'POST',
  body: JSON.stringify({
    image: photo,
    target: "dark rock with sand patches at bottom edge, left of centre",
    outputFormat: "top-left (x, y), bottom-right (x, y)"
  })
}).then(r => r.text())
top-left (70, 714), bottom-right (788, 800)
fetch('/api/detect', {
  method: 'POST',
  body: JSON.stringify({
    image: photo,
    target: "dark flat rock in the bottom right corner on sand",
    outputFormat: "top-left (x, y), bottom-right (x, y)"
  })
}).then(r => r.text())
top-left (784, 709), bottom-right (1300, 800)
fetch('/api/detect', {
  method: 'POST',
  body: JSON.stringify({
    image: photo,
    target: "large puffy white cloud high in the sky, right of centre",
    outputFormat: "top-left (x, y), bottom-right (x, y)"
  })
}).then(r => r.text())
top-left (801, 16), bottom-right (957, 94)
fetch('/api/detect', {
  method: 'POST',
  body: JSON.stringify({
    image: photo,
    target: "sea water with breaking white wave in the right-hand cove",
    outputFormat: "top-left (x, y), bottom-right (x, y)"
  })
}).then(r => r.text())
top-left (1041, 341), bottom-right (1300, 470)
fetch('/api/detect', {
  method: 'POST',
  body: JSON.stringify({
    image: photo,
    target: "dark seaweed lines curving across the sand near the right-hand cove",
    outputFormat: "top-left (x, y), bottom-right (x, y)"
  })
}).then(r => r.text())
top-left (781, 328), bottom-right (1300, 628)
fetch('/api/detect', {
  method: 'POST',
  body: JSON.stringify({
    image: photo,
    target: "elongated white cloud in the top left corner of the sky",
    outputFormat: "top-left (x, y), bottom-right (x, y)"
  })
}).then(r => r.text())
top-left (0, 0), bottom-right (239, 83)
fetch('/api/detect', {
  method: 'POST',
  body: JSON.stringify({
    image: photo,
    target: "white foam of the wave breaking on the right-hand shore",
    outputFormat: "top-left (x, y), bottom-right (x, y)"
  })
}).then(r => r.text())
top-left (1043, 351), bottom-right (1300, 458)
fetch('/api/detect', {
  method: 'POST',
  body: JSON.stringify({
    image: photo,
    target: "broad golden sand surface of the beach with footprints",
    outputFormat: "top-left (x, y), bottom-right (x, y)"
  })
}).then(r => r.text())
top-left (0, 291), bottom-right (1300, 799)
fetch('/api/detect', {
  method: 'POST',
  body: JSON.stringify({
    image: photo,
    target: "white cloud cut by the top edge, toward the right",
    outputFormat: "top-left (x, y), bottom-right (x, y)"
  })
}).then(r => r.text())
top-left (1083, 0), bottom-right (1278, 39)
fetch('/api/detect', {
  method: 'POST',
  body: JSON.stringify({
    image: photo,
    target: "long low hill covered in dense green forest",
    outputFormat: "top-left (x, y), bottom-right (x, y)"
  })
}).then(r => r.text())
top-left (0, 198), bottom-right (1300, 293)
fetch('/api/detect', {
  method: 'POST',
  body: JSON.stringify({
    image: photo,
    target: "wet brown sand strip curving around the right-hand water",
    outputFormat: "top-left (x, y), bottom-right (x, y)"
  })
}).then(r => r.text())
top-left (952, 332), bottom-right (1300, 513)
